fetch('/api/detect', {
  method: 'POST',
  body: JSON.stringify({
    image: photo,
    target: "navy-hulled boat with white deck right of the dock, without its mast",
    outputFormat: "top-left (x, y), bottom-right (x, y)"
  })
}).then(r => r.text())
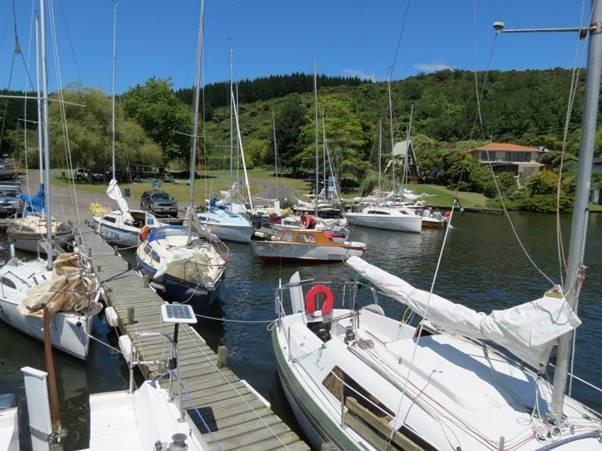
top-left (136, 226), bottom-right (229, 310)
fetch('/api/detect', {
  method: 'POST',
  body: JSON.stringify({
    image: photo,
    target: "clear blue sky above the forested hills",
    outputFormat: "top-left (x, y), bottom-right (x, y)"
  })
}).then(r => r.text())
top-left (0, 0), bottom-right (589, 92)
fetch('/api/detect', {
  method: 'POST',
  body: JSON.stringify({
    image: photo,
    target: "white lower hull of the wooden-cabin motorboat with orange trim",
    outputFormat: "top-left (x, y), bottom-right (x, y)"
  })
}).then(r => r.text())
top-left (253, 241), bottom-right (364, 262)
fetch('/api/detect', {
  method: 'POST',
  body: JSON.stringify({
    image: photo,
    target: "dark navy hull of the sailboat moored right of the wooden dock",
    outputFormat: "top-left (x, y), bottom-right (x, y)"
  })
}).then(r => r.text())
top-left (137, 257), bottom-right (224, 313)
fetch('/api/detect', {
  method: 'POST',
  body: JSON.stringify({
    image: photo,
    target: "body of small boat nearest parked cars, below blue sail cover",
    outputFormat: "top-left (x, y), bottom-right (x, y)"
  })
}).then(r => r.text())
top-left (6, 213), bottom-right (73, 254)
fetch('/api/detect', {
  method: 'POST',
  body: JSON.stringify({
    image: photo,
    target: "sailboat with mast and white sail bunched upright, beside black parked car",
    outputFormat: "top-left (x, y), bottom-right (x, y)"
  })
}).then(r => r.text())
top-left (93, 3), bottom-right (161, 247)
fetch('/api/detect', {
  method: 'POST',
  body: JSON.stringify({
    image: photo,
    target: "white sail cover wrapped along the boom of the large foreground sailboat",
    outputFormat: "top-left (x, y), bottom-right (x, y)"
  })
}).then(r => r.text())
top-left (347, 257), bottom-right (581, 367)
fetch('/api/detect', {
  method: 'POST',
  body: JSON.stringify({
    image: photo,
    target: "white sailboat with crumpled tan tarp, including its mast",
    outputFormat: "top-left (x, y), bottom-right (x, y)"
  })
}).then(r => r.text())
top-left (0, 6), bottom-right (101, 359)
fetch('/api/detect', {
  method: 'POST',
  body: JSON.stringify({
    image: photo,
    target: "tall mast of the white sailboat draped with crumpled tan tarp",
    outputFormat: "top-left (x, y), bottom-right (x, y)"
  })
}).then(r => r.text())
top-left (40, 0), bottom-right (53, 271)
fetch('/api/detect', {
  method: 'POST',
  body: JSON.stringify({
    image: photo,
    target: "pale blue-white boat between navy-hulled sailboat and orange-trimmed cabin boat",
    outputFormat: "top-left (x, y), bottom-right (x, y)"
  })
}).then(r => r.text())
top-left (197, 206), bottom-right (255, 243)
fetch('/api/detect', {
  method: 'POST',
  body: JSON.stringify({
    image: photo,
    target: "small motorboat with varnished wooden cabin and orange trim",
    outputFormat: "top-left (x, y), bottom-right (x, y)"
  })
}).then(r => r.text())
top-left (253, 228), bottom-right (366, 262)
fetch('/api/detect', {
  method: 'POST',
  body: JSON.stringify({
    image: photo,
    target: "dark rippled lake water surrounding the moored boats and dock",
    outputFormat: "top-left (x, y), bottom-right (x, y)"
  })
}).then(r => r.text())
top-left (0, 214), bottom-right (602, 449)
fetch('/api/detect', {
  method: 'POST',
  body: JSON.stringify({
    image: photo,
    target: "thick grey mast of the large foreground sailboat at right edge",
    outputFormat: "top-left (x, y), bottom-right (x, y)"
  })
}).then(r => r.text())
top-left (551, 0), bottom-right (602, 424)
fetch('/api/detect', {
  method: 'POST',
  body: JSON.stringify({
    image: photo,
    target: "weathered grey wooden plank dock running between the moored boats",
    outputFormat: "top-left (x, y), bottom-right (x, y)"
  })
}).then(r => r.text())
top-left (77, 226), bottom-right (309, 450)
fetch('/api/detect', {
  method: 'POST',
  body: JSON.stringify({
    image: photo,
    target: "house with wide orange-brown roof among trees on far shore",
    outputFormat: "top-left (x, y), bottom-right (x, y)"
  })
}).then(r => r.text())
top-left (469, 143), bottom-right (545, 177)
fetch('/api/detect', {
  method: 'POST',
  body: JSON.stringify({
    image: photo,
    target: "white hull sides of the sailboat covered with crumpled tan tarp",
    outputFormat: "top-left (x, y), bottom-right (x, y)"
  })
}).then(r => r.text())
top-left (0, 298), bottom-right (94, 359)
